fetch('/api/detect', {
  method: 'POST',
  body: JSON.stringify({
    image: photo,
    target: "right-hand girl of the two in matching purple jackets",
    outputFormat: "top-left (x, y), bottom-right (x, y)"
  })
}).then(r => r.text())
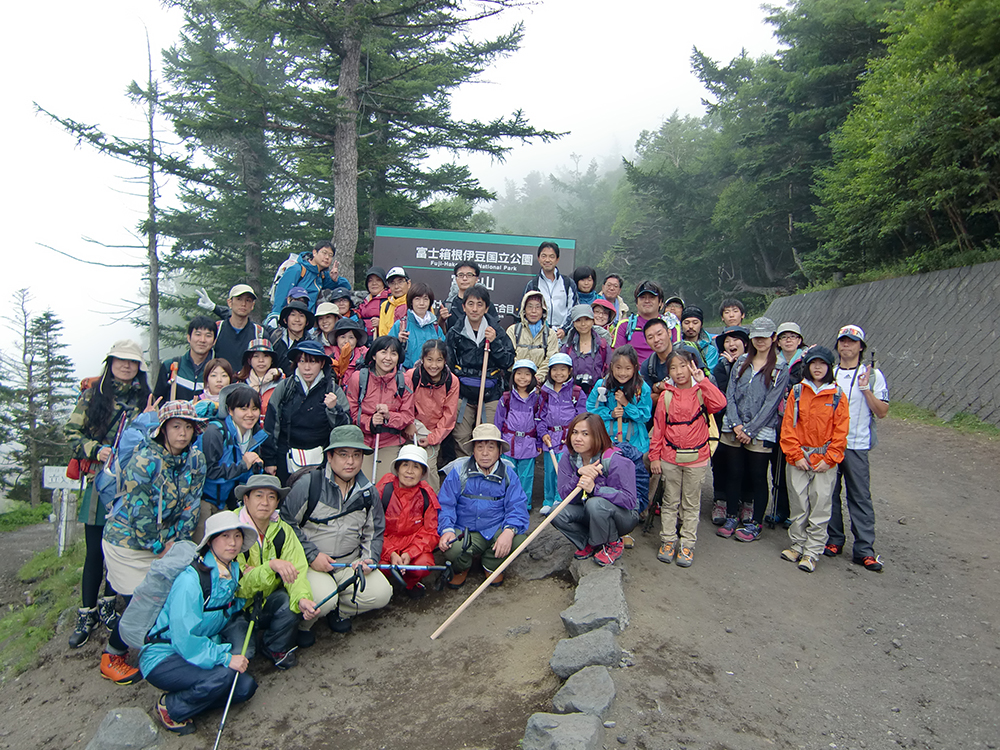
top-left (538, 353), bottom-right (587, 516)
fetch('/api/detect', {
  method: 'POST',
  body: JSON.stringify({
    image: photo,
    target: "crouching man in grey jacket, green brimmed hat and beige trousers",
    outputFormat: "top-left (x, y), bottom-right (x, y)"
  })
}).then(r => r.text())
top-left (281, 425), bottom-right (392, 636)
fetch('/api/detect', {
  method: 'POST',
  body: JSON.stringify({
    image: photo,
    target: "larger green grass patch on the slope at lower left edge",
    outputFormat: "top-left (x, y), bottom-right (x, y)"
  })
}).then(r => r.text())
top-left (0, 541), bottom-right (86, 679)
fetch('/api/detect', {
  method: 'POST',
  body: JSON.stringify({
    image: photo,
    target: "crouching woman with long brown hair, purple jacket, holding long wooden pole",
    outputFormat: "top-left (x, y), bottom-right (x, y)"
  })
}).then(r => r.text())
top-left (552, 414), bottom-right (639, 567)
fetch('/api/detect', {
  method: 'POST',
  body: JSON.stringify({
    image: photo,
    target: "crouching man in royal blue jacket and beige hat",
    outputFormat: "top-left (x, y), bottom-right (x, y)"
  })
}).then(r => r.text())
top-left (438, 424), bottom-right (528, 589)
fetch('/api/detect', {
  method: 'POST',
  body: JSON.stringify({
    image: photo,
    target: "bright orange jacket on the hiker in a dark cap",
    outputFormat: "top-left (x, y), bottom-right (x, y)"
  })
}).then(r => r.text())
top-left (781, 378), bottom-right (850, 466)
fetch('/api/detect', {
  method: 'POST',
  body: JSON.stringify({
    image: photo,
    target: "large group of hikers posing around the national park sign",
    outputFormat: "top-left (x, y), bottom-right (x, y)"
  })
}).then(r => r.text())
top-left (66, 242), bottom-right (888, 734)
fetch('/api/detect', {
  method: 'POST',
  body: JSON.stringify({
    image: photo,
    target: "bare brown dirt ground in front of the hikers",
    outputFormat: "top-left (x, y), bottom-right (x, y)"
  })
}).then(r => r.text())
top-left (0, 420), bottom-right (1000, 750)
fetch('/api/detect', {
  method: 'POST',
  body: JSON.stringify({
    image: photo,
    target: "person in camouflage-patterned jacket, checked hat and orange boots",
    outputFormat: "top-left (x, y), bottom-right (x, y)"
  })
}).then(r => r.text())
top-left (101, 401), bottom-right (205, 685)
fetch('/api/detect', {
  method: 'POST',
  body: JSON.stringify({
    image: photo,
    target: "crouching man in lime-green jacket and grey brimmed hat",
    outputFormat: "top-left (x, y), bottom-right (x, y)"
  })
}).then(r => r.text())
top-left (225, 474), bottom-right (317, 669)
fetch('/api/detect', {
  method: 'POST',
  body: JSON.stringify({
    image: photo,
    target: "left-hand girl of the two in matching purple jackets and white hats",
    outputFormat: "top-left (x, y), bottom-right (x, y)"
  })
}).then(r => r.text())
top-left (493, 359), bottom-right (542, 511)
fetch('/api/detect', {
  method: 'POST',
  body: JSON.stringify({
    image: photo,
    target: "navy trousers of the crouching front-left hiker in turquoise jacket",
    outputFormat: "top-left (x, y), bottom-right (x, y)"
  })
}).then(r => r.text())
top-left (145, 656), bottom-right (257, 721)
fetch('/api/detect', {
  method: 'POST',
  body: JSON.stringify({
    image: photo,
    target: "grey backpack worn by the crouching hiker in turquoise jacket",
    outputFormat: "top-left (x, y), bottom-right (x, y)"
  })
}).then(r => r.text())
top-left (118, 539), bottom-right (233, 648)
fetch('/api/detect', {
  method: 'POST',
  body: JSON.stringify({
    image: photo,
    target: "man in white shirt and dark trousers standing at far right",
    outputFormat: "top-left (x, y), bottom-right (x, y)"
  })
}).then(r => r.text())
top-left (823, 325), bottom-right (889, 572)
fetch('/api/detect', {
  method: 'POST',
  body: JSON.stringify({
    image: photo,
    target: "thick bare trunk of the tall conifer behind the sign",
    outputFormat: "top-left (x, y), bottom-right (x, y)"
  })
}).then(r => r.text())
top-left (333, 14), bottom-right (361, 286)
